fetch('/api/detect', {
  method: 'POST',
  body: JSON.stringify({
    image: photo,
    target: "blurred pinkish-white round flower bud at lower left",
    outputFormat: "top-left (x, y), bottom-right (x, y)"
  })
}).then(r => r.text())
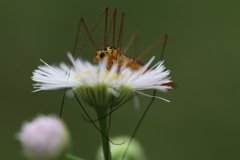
top-left (17, 115), bottom-right (70, 160)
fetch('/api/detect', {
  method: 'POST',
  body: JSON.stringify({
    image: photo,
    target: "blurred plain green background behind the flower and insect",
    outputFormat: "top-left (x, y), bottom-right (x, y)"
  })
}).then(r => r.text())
top-left (0, 0), bottom-right (240, 160)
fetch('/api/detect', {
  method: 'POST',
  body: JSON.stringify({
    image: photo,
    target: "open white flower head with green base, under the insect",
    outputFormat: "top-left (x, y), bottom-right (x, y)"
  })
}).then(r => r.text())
top-left (32, 53), bottom-right (171, 107)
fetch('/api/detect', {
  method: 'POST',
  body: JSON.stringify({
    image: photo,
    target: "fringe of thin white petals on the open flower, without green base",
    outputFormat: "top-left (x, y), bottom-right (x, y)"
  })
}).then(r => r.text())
top-left (32, 53), bottom-right (171, 94)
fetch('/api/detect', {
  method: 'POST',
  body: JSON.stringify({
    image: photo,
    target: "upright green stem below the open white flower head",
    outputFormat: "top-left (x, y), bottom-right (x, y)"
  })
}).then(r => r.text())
top-left (95, 107), bottom-right (112, 160)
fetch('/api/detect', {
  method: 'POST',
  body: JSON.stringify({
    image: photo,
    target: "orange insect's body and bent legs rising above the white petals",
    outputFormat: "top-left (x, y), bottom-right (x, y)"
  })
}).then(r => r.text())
top-left (73, 7), bottom-right (173, 86)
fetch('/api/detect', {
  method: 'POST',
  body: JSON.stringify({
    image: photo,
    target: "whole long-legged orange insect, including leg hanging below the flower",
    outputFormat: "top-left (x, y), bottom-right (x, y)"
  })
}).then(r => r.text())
top-left (63, 7), bottom-right (173, 160)
